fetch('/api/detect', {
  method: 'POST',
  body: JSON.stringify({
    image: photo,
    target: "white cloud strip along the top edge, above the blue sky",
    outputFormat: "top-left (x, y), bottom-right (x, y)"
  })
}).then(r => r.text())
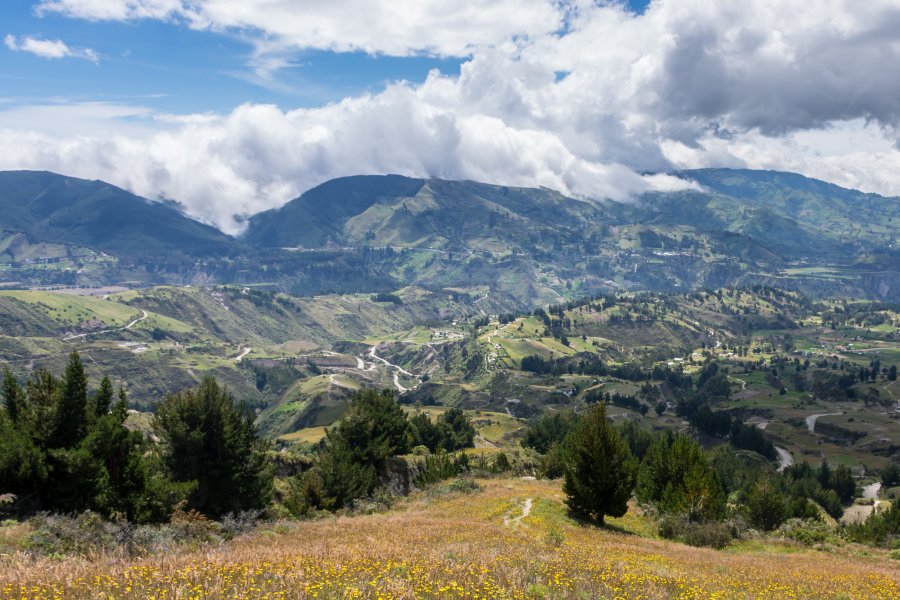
top-left (37, 0), bottom-right (562, 56)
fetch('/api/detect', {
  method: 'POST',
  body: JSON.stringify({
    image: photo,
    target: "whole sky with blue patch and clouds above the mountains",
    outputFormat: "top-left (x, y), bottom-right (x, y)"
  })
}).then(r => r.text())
top-left (0, 0), bottom-right (900, 234)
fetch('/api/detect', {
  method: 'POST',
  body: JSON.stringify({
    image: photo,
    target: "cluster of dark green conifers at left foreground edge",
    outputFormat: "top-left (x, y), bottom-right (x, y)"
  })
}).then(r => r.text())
top-left (0, 352), bottom-right (274, 523)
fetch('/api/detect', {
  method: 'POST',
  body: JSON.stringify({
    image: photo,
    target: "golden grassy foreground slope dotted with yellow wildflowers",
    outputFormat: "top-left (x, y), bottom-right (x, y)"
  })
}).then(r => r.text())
top-left (0, 480), bottom-right (900, 600)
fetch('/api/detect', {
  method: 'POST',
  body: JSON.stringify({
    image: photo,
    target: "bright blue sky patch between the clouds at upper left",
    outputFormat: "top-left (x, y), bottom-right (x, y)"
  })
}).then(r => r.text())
top-left (0, 0), bottom-right (649, 113)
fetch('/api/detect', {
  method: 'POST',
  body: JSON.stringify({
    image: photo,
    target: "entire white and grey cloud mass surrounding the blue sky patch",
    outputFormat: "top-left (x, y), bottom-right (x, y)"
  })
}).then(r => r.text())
top-left (0, 0), bottom-right (900, 232)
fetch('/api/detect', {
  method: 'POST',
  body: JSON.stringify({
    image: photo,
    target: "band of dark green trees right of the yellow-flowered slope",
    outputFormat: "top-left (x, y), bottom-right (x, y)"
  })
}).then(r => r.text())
top-left (522, 402), bottom-right (900, 546)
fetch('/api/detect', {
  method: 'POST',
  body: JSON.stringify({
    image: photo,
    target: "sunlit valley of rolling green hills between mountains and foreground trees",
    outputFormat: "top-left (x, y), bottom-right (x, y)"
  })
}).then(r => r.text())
top-left (0, 286), bottom-right (900, 494)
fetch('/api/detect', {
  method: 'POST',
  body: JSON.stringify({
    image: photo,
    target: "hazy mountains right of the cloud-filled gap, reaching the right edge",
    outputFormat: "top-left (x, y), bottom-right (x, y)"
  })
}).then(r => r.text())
top-left (244, 169), bottom-right (900, 305)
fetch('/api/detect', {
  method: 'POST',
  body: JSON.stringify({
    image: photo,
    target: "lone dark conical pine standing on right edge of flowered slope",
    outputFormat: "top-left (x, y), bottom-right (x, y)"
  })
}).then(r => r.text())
top-left (563, 402), bottom-right (635, 524)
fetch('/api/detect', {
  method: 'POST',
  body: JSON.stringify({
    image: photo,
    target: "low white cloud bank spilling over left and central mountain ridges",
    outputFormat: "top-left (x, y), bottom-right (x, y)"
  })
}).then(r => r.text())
top-left (0, 95), bottom-right (685, 233)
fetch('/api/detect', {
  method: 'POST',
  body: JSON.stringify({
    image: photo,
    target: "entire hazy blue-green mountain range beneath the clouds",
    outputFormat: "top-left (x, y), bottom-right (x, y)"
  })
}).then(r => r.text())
top-left (0, 169), bottom-right (900, 305)
